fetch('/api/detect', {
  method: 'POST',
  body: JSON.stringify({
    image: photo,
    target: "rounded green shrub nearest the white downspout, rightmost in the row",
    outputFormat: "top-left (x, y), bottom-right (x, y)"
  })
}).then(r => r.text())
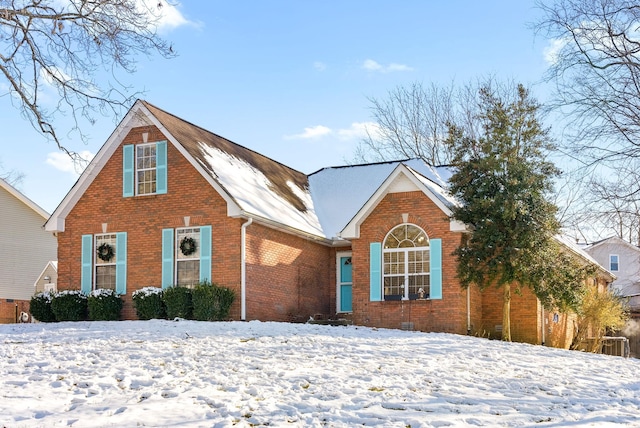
top-left (192, 282), bottom-right (235, 321)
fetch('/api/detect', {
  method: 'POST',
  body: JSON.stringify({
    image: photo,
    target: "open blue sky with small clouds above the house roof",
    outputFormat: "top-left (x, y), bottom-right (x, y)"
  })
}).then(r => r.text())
top-left (0, 0), bottom-right (550, 212)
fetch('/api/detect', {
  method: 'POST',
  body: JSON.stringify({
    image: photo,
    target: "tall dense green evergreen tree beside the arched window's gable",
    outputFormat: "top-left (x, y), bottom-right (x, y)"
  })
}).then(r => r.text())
top-left (448, 85), bottom-right (586, 340)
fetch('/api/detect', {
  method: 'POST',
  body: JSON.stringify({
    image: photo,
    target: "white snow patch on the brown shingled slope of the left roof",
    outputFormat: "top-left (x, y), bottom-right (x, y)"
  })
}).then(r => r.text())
top-left (200, 143), bottom-right (324, 236)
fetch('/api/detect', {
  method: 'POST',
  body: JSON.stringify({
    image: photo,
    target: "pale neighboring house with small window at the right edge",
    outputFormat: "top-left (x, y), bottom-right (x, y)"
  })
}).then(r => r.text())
top-left (585, 236), bottom-right (640, 312)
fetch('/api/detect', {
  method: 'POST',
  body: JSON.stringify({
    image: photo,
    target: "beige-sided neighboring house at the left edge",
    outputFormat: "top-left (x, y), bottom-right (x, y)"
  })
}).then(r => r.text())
top-left (0, 179), bottom-right (58, 303)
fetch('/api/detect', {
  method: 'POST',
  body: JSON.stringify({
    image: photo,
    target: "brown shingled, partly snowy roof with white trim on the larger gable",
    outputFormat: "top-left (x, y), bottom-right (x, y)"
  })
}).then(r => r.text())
top-left (47, 100), bottom-right (323, 237)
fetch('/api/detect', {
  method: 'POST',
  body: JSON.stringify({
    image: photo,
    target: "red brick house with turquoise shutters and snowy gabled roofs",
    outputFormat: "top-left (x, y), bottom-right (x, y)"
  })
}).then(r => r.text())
top-left (46, 101), bottom-right (606, 343)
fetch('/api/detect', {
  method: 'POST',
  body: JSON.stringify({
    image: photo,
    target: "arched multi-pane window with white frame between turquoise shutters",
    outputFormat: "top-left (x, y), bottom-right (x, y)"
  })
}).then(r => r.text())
top-left (382, 223), bottom-right (430, 300)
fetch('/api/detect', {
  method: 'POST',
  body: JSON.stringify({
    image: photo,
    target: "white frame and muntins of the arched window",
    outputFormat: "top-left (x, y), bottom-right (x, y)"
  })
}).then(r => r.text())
top-left (382, 223), bottom-right (431, 300)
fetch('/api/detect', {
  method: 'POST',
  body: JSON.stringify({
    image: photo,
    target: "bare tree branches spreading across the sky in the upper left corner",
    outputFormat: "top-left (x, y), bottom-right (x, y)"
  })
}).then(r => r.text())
top-left (0, 0), bottom-right (174, 160)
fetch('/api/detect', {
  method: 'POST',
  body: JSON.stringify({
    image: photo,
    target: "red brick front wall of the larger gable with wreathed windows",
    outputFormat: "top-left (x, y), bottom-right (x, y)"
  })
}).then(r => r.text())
top-left (58, 127), bottom-right (242, 319)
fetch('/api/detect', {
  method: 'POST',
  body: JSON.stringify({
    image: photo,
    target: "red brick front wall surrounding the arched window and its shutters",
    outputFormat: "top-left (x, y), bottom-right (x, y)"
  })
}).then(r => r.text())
top-left (352, 192), bottom-right (472, 334)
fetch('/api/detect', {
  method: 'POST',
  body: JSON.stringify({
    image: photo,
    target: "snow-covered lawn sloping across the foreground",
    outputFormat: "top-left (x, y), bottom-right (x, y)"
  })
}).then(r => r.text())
top-left (0, 320), bottom-right (640, 428)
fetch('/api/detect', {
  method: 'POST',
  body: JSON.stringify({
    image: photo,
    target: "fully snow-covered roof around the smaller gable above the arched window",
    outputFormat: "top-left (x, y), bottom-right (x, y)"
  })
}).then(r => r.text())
top-left (309, 159), bottom-right (452, 239)
